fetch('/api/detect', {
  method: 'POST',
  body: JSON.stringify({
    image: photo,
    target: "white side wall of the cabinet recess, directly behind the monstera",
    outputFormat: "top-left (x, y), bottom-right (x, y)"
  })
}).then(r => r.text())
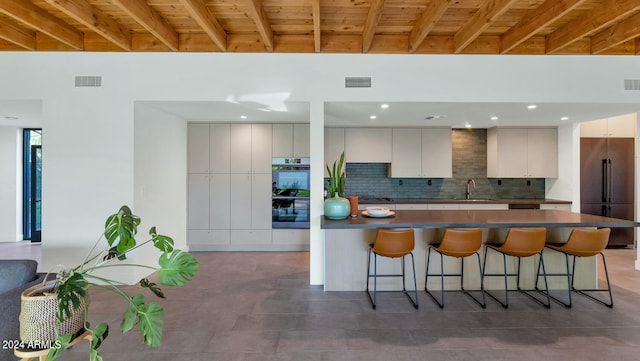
top-left (133, 104), bottom-right (188, 281)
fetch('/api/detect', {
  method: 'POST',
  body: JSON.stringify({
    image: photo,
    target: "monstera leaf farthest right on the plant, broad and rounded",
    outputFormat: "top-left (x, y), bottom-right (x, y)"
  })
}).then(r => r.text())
top-left (158, 249), bottom-right (198, 286)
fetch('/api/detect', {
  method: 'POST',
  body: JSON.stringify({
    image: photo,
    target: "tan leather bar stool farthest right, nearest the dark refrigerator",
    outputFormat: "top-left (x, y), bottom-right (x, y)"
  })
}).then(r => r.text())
top-left (546, 228), bottom-right (613, 307)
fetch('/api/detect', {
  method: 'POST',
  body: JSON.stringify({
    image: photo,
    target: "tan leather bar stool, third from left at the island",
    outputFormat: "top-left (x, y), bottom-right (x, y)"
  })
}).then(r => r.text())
top-left (482, 228), bottom-right (551, 308)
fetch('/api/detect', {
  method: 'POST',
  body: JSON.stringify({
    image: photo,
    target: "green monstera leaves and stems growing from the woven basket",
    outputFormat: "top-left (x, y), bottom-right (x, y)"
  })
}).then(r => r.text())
top-left (21, 206), bottom-right (198, 360)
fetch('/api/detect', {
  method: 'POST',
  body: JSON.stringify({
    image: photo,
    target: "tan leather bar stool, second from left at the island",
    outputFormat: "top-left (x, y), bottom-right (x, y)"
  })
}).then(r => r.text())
top-left (424, 228), bottom-right (487, 308)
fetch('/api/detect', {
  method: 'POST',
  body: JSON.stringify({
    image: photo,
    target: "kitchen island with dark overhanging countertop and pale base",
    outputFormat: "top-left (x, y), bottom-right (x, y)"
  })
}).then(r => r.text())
top-left (321, 209), bottom-right (640, 291)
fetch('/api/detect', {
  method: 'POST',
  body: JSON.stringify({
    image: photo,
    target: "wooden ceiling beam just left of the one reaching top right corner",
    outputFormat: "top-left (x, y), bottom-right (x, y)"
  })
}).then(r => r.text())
top-left (500, 0), bottom-right (586, 54)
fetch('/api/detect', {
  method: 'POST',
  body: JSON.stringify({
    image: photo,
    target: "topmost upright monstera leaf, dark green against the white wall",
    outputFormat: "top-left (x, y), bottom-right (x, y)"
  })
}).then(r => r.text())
top-left (104, 206), bottom-right (140, 253)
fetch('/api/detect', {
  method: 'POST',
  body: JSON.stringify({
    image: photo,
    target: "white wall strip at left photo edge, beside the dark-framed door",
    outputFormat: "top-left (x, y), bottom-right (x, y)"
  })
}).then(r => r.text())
top-left (0, 127), bottom-right (22, 242)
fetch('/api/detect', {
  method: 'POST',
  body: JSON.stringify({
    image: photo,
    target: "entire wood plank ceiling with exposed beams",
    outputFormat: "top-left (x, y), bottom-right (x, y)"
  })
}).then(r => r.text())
top-left (0, 0), bottom-right (640, 55)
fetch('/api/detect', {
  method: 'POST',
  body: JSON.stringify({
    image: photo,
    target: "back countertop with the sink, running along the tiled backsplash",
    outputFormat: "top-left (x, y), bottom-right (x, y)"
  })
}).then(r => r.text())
top-left (358, 198), bottom-right (572, 204)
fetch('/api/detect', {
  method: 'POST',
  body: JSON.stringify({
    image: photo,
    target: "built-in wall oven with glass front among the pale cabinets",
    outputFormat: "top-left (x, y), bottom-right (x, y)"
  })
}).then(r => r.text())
top-left (271, 158), bottom-right (310, 228)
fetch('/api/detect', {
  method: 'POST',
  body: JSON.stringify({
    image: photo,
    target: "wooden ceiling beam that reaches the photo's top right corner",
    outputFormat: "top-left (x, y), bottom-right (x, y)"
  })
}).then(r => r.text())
top-left (546, 0), bottom-right (640, 54)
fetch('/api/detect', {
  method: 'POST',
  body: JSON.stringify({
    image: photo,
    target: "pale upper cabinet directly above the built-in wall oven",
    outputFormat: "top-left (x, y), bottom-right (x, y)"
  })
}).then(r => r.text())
top-left (273, 123), bottom-right (309, 158)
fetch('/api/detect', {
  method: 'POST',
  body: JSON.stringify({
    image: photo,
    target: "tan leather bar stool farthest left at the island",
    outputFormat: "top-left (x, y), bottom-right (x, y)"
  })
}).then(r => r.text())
top-left (367, 229), bottom-right (418, 310)
